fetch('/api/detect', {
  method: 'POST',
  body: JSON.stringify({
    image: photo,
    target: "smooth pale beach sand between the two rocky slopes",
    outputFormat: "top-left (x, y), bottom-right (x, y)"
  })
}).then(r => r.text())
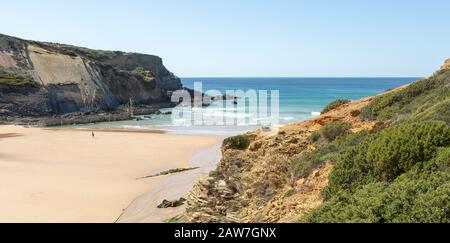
top-left (0, 126), bottom-right (223, 222)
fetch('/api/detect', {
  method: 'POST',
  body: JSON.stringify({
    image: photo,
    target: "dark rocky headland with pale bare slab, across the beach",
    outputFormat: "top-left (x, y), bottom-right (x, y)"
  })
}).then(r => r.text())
top-left (0, 34), bottom-right (182, 125)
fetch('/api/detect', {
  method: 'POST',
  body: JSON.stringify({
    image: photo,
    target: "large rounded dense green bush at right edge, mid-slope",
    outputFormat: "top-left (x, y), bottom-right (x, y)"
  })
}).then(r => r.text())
top-left (367, 122), bottom-right (450, 181)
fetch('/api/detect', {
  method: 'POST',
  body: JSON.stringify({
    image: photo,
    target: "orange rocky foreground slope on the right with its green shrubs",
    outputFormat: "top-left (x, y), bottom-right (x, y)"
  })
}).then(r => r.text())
top-left (183, 61), bottom-right (450, 223)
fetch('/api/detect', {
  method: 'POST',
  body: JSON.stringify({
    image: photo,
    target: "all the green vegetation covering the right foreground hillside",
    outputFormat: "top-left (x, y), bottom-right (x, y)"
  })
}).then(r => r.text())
top-left (293, 70), bottom-right (450, 223)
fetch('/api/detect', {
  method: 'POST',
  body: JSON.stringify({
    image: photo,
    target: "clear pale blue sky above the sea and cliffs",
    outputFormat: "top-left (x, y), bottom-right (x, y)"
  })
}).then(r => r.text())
top-left (0, 0), bottom-right (450, 77)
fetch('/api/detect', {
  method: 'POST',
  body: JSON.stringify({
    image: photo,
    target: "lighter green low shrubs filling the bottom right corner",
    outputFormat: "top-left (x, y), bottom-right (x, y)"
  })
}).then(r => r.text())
top-left (301, 168), bottom-right (450, 223)
